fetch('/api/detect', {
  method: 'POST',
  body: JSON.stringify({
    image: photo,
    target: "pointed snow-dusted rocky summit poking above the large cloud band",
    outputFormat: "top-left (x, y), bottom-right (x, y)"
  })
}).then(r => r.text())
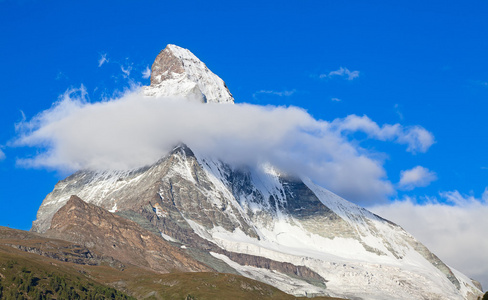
top-left (144, 44), bottom-right (234, 103)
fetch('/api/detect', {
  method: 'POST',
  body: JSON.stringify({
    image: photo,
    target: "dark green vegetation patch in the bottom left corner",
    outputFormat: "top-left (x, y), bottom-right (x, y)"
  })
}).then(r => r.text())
top-left (0, 259), bottom-right (135, 300)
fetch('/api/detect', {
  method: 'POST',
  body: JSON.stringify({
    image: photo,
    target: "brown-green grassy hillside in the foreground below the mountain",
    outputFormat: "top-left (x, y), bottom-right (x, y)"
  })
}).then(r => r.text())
top-left (0, 227), bottom-right (344, 299)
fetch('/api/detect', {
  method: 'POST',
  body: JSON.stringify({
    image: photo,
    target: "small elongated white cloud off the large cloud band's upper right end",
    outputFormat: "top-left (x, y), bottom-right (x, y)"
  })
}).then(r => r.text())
top-left (331, 115), bottom-right (434, 153)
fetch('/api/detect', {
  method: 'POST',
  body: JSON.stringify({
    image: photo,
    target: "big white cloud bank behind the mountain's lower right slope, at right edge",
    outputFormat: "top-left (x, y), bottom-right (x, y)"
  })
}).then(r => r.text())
top-left (370, 188), bottom-right (488, 289)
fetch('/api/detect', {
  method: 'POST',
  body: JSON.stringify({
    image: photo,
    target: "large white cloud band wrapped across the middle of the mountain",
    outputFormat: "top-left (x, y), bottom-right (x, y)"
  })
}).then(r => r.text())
top-left (11, 88), bottom-right (432, 204)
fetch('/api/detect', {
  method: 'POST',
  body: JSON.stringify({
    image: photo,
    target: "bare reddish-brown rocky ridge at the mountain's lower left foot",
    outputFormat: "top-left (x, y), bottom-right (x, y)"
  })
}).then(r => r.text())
top-left (46, 196), bottom-right (211, 273)
